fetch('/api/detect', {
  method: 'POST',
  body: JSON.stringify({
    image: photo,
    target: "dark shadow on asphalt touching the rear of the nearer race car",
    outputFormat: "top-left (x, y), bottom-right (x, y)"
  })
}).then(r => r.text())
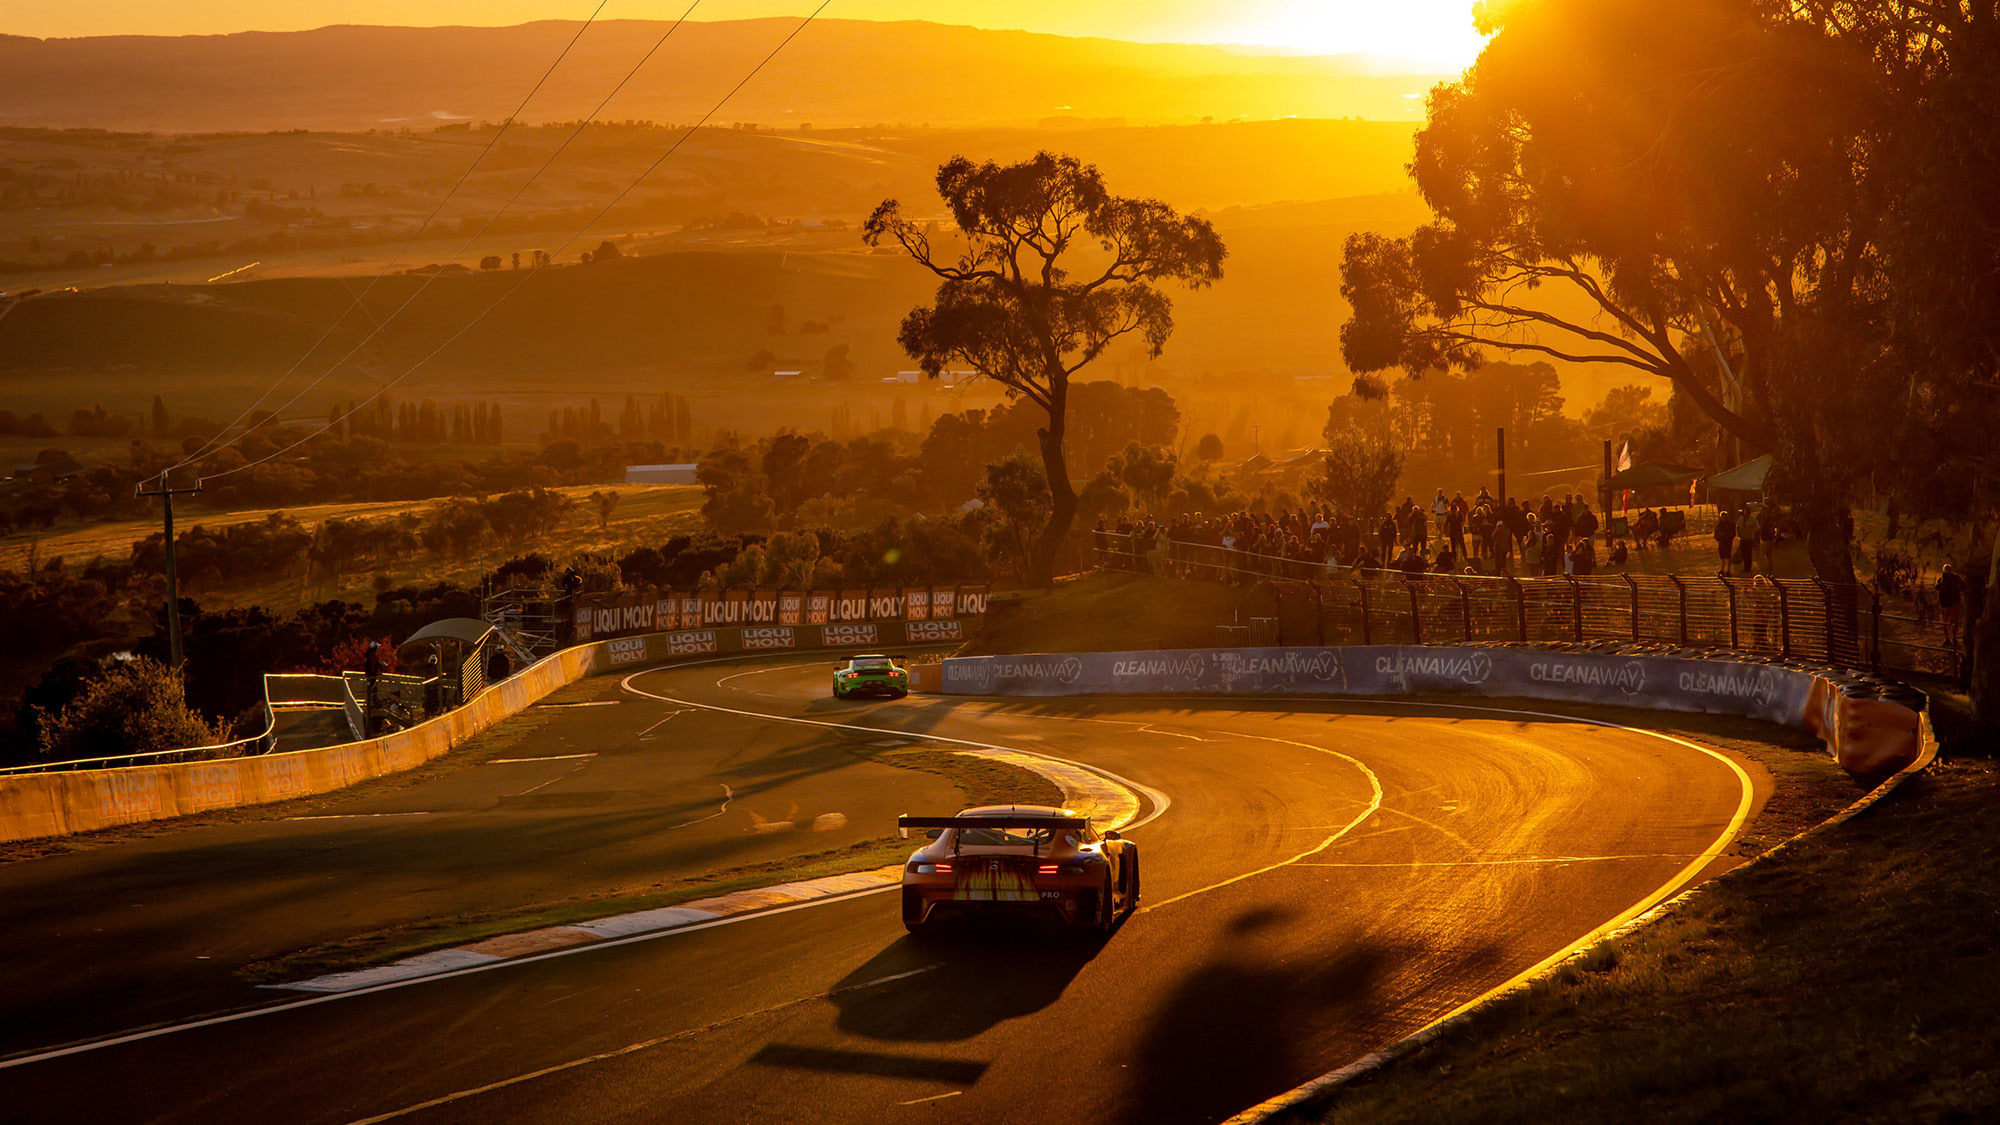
top-left (834, 921), bottom-right (1106, 1043)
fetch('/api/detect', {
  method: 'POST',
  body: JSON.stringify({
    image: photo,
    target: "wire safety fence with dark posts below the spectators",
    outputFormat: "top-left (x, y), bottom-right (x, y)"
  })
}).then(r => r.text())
top-left (1096, 532), bottom-right (1960, 677)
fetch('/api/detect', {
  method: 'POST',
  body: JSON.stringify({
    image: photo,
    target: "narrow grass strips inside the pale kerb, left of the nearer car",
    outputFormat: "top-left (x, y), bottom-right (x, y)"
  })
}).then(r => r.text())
top-left (236, 745), bottom-right (1062, 985)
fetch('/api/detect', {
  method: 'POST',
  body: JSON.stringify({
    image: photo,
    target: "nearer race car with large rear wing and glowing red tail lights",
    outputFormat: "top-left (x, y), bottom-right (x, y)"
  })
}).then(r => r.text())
top-left (896, 805), bottom-right (1138, 933)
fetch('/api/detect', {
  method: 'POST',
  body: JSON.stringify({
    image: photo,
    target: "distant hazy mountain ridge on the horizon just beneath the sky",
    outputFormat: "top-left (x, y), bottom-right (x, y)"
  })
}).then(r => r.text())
top-left (0, 20), bottom-right (1436, 132)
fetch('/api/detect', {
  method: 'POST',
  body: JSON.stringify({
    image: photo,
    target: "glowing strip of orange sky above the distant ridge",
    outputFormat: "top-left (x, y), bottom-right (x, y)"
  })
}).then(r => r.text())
top-left (15, 0), bottom-right (1478, 66)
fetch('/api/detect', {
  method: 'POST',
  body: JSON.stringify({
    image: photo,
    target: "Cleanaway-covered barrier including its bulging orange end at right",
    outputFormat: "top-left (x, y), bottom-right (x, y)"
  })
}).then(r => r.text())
top-left (910, 645), bottom-right (1926, 773)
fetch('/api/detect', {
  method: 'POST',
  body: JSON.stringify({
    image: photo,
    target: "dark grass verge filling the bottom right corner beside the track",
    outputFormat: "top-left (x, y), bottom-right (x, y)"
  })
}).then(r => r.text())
top-left (1318, 761), bottom-right (2000, 1125)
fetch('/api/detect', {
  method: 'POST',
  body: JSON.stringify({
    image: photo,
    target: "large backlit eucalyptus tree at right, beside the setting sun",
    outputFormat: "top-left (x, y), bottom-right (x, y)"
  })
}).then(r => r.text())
top-left (1340, 0), bottom-right (1908, 596)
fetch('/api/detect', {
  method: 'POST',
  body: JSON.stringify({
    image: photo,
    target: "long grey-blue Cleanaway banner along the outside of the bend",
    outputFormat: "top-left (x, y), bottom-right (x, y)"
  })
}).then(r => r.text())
top-left (928, 645), bottom-right (1814, 727)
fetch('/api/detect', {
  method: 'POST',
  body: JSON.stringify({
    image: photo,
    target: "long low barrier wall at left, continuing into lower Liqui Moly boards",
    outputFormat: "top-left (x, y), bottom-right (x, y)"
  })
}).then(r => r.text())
top-left (0, 619), bottom-right (968, 843)
